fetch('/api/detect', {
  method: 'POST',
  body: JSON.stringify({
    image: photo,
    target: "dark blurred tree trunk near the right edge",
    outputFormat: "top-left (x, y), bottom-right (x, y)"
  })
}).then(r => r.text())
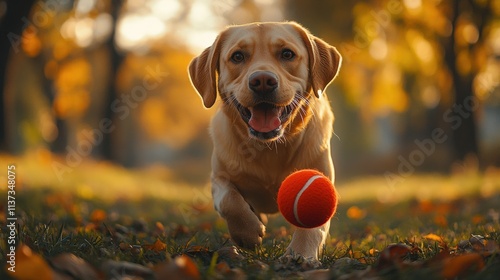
top-left (443, 0), bottom-right (494, 161)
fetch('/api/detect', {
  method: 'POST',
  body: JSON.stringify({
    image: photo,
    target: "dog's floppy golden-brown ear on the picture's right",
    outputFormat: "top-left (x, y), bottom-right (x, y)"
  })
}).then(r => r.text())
top-left (292, 23), bottom-right (342, 97)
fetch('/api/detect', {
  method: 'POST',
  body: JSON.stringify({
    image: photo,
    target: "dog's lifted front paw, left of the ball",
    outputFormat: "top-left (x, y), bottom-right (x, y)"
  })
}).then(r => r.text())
top-left (227, 213), bottom-right (266, 249)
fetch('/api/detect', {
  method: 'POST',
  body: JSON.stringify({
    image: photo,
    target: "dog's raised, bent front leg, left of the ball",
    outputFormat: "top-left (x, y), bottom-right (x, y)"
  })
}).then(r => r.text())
top-left (212, 177), bottom-right (266, 249)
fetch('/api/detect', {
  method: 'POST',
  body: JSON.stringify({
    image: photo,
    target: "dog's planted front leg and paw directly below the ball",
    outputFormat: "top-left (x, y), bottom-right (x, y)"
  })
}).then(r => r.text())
top-left (285, 221), bottom-right (330, 260)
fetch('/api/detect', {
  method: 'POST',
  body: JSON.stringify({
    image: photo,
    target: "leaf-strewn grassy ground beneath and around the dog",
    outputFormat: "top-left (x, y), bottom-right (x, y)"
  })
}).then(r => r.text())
top-left (0, 150), bottom-right (500, 279)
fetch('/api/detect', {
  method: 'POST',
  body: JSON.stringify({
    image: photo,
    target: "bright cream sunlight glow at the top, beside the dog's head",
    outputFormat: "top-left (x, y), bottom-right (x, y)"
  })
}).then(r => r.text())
top-left (115, 0), bottom-right (283, 53)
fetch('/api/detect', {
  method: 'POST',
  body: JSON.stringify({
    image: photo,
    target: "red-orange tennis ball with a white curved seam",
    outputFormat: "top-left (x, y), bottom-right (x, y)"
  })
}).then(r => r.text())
top-left (278, 169), bottom-right (337, 228)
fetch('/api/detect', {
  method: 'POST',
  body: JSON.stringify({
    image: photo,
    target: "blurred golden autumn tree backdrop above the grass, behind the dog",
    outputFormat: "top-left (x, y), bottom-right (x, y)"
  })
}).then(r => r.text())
top-left (0, 0), bottom-right (500, 184)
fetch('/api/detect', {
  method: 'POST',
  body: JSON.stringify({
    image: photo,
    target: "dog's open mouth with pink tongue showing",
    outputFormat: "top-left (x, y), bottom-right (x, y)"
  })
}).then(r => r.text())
top-left (236, 102), bottom-right (293, 140)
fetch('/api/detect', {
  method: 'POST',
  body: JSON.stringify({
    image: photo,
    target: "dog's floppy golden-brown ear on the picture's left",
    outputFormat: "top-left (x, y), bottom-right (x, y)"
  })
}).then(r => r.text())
top-left (189, 36), bottom-right (220, 108)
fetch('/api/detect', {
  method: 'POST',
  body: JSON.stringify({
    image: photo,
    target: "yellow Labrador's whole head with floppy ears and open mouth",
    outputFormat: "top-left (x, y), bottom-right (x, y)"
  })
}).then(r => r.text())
top-left (189, 22), bottom-right (341, 141)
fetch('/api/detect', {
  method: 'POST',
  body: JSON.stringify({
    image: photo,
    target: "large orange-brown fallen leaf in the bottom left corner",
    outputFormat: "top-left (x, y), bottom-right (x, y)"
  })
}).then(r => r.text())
top-left (7, 244), bottom-right (54, 280)
